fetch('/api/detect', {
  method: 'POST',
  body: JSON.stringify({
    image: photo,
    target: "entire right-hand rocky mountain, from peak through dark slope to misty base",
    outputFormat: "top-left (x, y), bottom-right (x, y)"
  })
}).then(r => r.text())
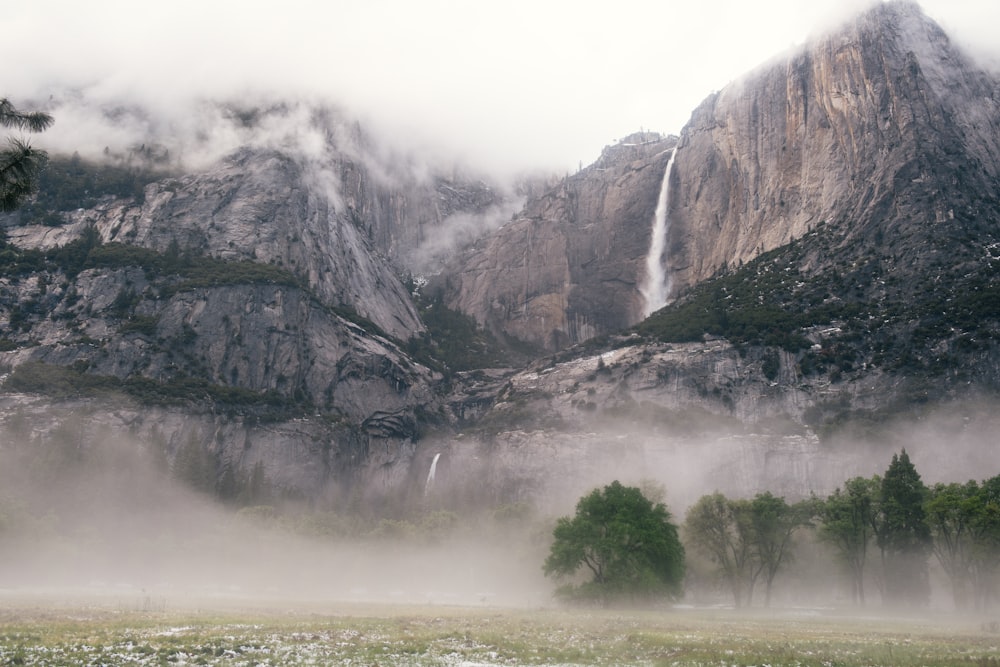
top-left (426, 2), bottom-right (1000, 506)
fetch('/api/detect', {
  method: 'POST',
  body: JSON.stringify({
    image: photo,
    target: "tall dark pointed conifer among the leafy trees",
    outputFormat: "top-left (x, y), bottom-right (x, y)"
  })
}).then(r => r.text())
top-left (876, 449), bottom-right (932, 605)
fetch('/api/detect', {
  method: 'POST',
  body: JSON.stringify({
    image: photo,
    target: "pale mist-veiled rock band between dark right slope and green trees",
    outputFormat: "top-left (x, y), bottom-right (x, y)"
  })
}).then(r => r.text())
top-left (434, 340), bottom-right (996, 514)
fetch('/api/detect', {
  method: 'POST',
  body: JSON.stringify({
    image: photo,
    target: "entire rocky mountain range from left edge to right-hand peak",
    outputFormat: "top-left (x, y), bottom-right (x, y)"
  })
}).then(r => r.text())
top-left (0, 2), bottom-right (1000, 511)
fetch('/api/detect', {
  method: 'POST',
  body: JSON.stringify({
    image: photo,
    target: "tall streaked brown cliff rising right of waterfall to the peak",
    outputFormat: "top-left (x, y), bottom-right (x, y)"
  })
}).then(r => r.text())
top-left (668, 2), bottom-right (1000, 289)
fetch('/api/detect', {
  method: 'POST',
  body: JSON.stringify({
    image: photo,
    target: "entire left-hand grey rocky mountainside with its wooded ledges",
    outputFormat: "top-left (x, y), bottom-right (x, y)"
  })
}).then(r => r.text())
top-left (0, 109), bottom-right (505, 506)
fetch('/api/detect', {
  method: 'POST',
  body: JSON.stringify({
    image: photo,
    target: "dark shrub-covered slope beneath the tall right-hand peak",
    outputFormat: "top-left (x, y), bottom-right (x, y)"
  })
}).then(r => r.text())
top-left (635, 223), bottom-right (1000, 382)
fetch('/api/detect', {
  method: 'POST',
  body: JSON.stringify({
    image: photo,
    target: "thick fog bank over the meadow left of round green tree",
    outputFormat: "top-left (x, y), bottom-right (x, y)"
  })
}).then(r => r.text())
top-left (0, 424), bottom-right (549, 608)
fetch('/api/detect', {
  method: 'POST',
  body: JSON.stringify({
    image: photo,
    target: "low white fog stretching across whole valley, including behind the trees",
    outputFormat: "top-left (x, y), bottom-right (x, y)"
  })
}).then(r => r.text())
top-left (0, 396), bottom-right (1000, 608)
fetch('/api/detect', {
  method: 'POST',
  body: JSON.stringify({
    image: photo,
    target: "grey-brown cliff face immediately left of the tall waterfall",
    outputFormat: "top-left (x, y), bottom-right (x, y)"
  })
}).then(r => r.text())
top-left (432, 134), bottom-right (674, 350)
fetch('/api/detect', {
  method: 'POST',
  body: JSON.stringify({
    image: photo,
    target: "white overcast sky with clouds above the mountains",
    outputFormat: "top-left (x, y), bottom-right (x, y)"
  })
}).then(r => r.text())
top-left (0, 0), bottom-right (1000, 177)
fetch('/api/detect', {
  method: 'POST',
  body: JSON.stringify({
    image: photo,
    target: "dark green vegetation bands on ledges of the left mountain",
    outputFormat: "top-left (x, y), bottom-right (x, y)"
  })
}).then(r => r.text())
top-left (0, 228), bottom-right (352, 421)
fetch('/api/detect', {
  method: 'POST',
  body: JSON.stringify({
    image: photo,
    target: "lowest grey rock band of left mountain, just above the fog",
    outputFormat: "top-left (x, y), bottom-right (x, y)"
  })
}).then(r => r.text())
top-left (0, 393), bottom-right (415, 507)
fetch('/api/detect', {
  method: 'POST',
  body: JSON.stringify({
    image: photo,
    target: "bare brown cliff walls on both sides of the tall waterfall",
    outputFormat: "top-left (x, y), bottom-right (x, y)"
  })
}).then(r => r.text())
top-left (445, 2), bottom-right (1000, 350)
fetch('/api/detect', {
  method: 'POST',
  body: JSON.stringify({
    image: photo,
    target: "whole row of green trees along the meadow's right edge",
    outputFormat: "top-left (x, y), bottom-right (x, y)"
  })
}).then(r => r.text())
top-left (543, 449), bottom-right (1000, 610)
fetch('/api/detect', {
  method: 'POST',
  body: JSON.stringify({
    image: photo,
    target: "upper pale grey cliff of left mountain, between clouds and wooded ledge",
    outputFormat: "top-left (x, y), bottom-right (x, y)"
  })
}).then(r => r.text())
top-left (7, 141), bottom-right (501, 340)
